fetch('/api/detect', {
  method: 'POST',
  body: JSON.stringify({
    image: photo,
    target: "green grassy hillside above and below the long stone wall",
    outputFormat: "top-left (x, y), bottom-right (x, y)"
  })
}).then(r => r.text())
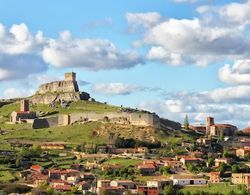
top-left (0, 101), bottom-right (195, 149)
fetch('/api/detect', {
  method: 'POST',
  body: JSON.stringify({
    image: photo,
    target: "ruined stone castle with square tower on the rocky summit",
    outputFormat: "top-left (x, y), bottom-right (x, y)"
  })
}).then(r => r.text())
top-left (29, 72), bottom-right (90, 104)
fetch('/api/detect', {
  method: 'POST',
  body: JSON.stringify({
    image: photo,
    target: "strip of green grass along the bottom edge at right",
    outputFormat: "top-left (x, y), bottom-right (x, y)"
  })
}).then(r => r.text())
top-left (181, 183), bottom-right (245, 194)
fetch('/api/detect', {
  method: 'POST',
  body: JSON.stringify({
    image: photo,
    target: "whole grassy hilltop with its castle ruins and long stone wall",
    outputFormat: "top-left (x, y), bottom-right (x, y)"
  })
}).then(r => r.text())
top-left (0, 73), bottom-right (184, 148)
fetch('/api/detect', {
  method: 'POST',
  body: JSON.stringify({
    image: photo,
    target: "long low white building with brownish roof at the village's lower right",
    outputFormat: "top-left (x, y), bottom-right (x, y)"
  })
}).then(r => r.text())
top-left (172, 175), bottom-right (207, 186)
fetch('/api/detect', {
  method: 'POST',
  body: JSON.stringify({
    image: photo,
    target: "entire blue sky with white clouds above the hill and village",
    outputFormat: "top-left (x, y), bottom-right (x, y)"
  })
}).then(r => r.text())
top-left (0, 0), bottom-right (250, 128)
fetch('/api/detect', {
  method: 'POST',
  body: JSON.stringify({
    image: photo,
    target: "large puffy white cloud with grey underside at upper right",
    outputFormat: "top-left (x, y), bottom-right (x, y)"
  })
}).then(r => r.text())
top-left (143, 18), bottom-right (250, 66)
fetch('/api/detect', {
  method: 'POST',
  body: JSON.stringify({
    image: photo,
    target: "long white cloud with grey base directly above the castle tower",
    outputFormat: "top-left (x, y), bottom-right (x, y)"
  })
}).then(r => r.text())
top-left (42, 32), bottom-right (143, 71)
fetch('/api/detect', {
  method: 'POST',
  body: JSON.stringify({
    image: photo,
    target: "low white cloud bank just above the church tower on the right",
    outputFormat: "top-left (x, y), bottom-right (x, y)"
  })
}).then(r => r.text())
top-left (138, 85), bottom-right (250, 128)
